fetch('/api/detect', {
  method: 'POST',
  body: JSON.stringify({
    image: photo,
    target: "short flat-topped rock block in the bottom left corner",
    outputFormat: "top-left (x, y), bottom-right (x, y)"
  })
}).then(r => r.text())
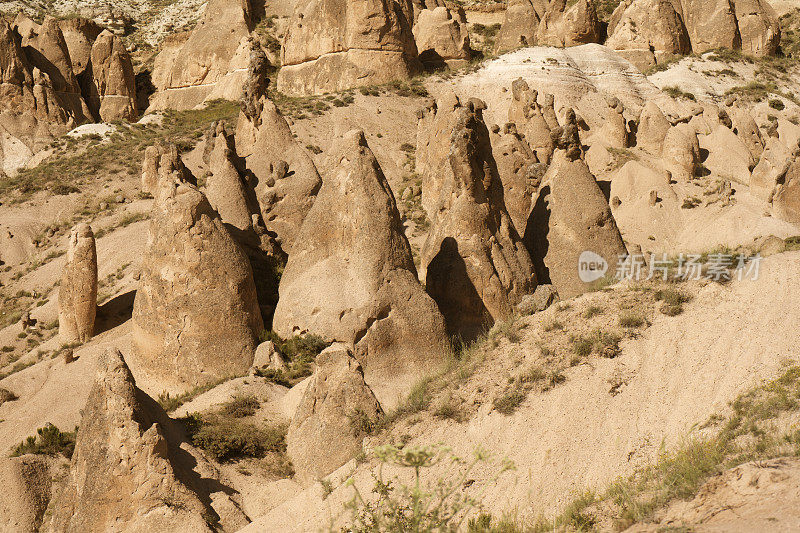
top-left (0, 455), bottom-right (58, 533)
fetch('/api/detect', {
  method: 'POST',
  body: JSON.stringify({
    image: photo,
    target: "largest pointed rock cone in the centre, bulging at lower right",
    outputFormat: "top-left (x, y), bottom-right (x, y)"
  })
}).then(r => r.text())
top-left (273, 131), bottom-right (447, 405)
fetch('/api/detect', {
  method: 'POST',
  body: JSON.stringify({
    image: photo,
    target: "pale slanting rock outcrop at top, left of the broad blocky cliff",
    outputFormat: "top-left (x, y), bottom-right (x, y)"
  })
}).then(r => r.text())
top-left (149, 0), bottom-right (257, 110)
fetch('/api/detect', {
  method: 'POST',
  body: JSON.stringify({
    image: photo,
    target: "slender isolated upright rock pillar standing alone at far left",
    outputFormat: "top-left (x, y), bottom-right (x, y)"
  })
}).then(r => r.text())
top-left (58, 224), bottom-right (97, 342)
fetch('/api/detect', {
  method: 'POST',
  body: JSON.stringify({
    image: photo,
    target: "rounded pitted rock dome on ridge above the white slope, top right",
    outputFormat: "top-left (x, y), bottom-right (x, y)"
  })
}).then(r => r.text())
top-left (605, 0), bottom-right (692, 70)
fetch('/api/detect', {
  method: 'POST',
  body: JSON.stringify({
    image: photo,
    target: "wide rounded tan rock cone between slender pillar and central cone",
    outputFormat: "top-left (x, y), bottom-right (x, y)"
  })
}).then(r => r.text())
top-left (132, 162), bottom-right (264, 391)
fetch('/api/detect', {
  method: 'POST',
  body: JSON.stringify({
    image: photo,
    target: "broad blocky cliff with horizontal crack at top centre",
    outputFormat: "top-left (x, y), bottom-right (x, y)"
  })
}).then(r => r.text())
top-left (278, 0), bottom-right (421, 95)
